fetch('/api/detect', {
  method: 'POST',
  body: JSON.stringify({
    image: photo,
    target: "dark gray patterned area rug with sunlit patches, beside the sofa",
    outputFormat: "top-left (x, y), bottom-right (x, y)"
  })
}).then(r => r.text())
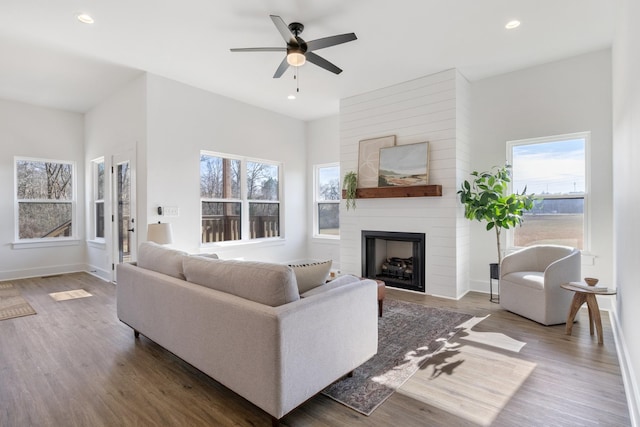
top-left (322, 300), bottom-right (473, 415)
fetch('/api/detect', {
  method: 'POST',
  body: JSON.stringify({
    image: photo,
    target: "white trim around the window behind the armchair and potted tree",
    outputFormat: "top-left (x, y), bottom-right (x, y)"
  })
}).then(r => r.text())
top-left (505, 131), bottom-right (591, 251)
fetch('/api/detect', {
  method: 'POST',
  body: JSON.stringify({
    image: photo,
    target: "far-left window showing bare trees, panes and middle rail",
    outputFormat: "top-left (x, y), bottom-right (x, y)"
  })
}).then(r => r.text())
top-left (15, 158), bottom-right (75, 240)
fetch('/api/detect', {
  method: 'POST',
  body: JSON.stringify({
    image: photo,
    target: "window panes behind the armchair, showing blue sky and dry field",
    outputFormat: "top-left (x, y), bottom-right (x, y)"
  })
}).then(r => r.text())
top-left (507, 132), bottom-right (589, 250)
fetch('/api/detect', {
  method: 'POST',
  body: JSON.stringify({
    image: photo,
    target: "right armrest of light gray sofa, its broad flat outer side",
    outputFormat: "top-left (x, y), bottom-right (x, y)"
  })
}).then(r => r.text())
top-left (278, 280), bottom-right (378, 413)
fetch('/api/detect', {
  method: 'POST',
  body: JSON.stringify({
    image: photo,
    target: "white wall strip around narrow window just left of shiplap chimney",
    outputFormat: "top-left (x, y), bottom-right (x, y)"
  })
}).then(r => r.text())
top-left (306, 116), bottom-right (342, 270)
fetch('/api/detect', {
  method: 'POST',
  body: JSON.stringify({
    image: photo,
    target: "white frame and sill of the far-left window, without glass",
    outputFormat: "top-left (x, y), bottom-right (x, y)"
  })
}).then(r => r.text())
top-left (13, 156), bottom-right (79, 244)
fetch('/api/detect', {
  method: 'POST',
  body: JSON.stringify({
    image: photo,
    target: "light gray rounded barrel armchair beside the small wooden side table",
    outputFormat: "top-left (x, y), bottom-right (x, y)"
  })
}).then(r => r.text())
top-left (500, 245), bottom-right (581, 325)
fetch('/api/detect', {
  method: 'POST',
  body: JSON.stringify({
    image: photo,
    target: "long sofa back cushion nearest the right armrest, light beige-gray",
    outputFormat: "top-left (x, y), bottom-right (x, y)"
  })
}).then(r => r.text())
top-left (183, 256), bottom-right (300, 307)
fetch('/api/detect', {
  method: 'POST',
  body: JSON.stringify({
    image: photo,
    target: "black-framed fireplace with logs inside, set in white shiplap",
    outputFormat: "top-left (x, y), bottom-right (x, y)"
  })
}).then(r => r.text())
top-left (362, 230), bottom-right (425, 292)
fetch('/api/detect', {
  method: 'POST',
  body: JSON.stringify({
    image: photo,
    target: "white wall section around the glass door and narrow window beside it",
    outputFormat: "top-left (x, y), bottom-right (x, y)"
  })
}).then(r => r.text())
top-left (85, 75), bottom-right (146, 280)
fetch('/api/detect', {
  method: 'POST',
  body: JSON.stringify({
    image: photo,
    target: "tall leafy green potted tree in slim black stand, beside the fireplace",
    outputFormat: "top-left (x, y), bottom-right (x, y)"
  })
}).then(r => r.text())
top-left (458, 164), bottom-right (535, 292)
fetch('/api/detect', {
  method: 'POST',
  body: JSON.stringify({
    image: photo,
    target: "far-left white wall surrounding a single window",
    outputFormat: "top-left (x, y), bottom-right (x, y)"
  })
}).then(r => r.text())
top-left (0, 100), bottom-right (85, 280)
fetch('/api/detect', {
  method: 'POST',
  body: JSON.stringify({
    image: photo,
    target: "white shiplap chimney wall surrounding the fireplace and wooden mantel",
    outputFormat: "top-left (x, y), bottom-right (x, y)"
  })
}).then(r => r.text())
top-left (340, 69), bottom-right (470, 298)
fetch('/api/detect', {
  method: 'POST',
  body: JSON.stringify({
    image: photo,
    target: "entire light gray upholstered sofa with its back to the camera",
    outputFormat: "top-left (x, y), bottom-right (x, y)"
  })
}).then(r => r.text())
top-left (116, 243), bottom-right (378, 424)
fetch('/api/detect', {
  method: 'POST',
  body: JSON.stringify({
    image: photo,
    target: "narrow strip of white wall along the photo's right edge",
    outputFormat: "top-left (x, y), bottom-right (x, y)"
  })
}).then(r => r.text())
top-left (613, 0), bottom-right (640, 425)
